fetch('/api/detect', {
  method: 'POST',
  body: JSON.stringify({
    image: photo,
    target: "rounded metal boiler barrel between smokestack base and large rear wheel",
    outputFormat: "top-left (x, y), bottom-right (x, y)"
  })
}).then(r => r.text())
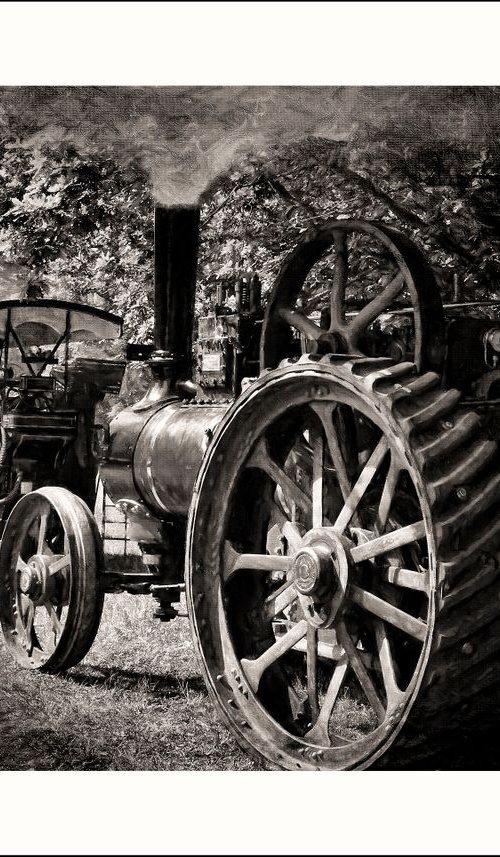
top-left (133, 402), bottom-right (228, 517)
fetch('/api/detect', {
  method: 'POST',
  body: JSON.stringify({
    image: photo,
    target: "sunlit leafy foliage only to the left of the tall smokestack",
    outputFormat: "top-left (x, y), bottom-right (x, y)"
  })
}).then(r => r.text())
top-left (0, 143), bottom-right (153, 339)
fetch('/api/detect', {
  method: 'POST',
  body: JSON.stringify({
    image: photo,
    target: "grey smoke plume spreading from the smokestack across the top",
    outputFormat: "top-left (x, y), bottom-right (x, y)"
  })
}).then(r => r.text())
top-left (0, 86), bottom-right (500, 205)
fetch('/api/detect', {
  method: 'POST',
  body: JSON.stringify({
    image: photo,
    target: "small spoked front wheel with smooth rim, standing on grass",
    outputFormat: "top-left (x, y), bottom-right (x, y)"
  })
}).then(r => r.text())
top-left (0, 486), bottom-right (104, 673)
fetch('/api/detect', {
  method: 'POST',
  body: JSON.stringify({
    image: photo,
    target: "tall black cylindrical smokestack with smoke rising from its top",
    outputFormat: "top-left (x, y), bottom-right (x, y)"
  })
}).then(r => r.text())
top-left (153, 206), bottom-right (200, 384)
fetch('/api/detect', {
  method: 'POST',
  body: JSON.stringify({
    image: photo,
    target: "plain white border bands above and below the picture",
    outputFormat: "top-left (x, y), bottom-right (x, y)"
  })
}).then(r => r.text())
top-left (0, 2), bottom-right (500, 855)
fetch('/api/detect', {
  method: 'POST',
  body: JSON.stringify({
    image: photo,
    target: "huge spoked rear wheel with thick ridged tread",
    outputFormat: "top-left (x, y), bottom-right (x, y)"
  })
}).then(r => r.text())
top-left (186, 355), bottom-right (500, 770)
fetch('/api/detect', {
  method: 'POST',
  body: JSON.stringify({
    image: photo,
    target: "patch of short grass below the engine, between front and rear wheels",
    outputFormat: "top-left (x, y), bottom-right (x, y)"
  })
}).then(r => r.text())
top-left (0, 595), bottom-right (256, 771)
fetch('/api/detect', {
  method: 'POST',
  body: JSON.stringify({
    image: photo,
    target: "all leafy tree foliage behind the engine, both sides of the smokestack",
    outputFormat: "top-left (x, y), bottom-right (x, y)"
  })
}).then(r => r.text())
top-left (0, 134), bottom-right (500, 341)
